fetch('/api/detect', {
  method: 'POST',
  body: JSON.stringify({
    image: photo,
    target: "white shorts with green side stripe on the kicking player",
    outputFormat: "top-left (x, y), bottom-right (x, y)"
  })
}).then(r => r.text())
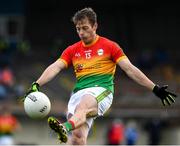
top-left (67, 87), bottom-right (113, 128)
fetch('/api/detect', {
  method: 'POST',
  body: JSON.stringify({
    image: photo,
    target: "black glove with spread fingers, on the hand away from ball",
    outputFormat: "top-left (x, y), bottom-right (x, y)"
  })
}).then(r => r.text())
top-left (153, 85), bottom-right (177, 106)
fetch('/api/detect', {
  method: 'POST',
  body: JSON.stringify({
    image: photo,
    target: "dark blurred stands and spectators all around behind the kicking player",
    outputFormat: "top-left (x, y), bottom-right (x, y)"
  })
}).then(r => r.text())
top-left (0, 0), bottom-right (180, 145)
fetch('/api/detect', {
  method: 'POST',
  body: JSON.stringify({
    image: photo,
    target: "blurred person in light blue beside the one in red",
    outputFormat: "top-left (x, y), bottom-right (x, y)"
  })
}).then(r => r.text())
top-left (125, 121), bottom-right (138, 145)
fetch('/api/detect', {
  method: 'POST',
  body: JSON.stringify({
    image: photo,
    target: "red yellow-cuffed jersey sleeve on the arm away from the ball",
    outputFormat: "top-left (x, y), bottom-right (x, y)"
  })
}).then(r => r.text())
top-left (111, 42), bottom-right (126, 63)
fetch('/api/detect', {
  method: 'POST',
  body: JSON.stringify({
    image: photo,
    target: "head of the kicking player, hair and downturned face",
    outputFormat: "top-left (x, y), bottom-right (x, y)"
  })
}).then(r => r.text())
top-left (72, 8), bottom-right (97, 44)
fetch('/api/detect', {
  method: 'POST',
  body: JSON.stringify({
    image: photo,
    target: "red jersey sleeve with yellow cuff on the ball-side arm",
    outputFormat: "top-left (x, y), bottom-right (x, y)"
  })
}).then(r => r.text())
top-left (59, 46), bottom-right (73, 67)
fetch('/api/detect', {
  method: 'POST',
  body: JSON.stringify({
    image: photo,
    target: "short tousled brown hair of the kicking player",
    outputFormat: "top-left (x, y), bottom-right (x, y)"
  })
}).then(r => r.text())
top-left (72, 8), bottom-right (97, 26)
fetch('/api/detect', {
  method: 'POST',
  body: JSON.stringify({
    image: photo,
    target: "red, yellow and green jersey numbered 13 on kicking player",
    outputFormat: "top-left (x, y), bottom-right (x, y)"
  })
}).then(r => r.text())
top-left (60, 36), bottom-right (126, 92)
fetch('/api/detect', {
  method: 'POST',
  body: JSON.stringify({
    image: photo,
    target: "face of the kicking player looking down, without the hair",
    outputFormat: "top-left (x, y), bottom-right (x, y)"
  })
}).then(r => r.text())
top-left (76, 18), bottom-right (97, 44)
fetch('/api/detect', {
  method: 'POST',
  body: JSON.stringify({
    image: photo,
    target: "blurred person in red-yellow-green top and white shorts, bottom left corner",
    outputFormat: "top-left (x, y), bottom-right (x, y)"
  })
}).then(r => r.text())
top-left (0, 105), bottom-right (20, 145)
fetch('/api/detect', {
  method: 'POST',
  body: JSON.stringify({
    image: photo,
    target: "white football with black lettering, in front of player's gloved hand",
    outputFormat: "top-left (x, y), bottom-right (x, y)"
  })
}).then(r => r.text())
top-left (24, 91), bottom-right (51, 119)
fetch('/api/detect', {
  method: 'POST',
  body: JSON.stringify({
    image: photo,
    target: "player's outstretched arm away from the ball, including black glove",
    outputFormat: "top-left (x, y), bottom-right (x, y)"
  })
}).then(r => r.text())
top-left (117, 58), bottom-right (177, 105)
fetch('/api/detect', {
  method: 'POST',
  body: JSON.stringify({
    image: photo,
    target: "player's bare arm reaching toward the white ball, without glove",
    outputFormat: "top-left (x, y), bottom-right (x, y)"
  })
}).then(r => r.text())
top-left (36, 59), bottom-right (66, 86)
